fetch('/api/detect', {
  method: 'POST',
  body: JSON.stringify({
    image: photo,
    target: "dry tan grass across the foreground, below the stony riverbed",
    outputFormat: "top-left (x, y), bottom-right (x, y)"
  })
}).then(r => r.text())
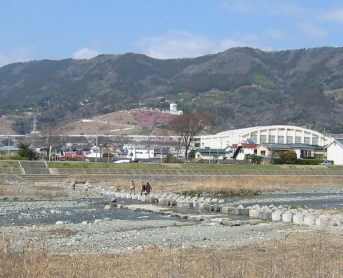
top-left (0, 233), bottom-right (343, 278)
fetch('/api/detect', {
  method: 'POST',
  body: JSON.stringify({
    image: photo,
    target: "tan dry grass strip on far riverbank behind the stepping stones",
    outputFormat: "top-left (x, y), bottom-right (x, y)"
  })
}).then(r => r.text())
top-left (110, 176), bottom-right (343, 193)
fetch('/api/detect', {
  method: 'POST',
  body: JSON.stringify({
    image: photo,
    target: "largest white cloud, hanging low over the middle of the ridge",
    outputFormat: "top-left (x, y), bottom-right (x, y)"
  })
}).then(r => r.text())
top-left (137, 32), bottom-right (258, 59)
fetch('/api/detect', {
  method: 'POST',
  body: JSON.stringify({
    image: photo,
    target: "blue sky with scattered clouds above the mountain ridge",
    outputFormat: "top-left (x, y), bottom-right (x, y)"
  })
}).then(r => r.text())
top-left (0, 0), bottom-right (343, 66)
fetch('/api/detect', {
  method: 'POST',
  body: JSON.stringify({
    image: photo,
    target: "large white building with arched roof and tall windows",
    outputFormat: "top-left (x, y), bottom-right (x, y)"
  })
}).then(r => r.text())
top-left (200, 125), bottom-right (333, 149)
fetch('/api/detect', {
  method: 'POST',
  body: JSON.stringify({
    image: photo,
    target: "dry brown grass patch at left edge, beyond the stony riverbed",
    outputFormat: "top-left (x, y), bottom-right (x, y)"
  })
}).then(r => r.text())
top-left (0, 185), bottom-right (69, 199)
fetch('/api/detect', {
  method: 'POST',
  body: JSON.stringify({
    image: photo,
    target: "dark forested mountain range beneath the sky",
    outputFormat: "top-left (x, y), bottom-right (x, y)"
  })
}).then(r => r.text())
top-left (0, 47), bottom-right (343, 133)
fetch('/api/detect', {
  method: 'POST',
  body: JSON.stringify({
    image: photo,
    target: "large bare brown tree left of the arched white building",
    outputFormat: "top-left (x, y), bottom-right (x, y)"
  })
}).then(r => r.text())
top-left (169, 113), bottom-right (210, 159)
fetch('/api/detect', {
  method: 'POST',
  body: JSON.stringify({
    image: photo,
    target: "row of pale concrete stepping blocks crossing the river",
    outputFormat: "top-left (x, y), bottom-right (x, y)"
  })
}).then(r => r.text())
top-left (106, 192), bottom-right (343, 226)
